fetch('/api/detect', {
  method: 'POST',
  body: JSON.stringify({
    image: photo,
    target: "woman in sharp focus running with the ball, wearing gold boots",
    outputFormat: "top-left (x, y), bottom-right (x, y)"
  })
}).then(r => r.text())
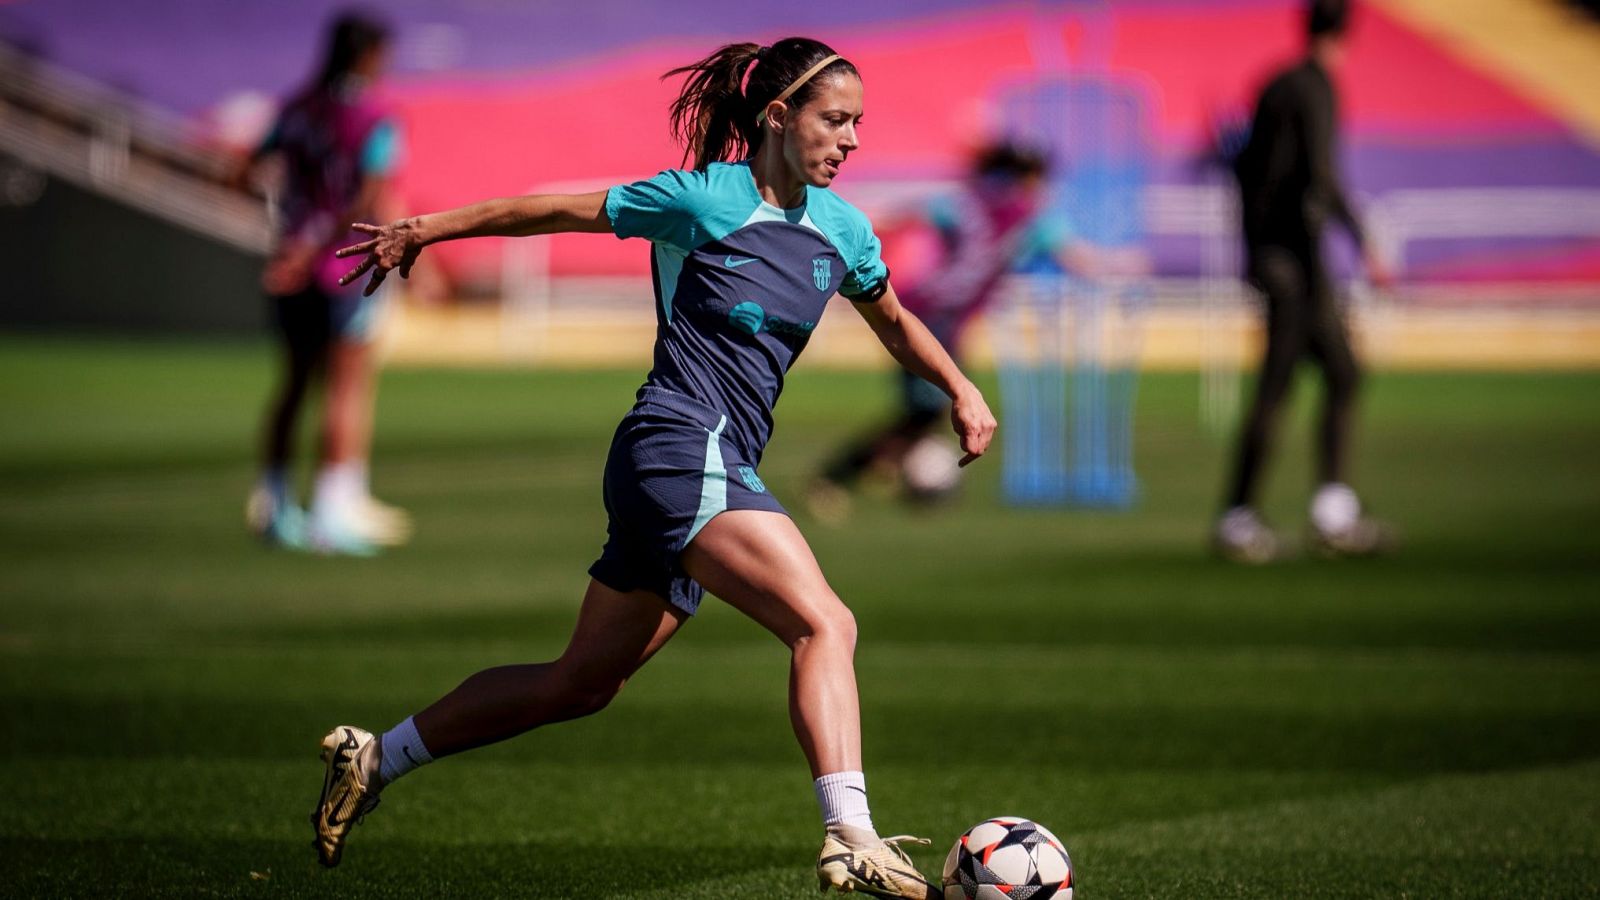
top-left (312, 38), bottom-right (995, 898)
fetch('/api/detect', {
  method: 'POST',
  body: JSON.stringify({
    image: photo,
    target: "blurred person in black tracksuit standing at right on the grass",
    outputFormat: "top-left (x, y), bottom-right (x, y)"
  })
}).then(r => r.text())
top-left (1213, 0), bottom-right (1389, 562)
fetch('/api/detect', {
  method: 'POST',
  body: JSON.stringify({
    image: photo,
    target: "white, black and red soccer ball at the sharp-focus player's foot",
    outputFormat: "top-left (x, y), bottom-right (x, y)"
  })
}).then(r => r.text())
top-left (944, 815), bottom-right (1072, 900)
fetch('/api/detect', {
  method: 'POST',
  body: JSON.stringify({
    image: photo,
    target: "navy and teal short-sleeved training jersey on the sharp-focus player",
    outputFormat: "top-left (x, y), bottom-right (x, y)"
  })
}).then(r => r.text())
top-left (605, 162), bottom-right (888, 460)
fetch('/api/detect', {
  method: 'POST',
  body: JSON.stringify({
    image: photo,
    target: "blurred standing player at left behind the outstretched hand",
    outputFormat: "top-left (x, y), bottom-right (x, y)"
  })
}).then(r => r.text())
top-left (240, 11), bottom-right (411, 556)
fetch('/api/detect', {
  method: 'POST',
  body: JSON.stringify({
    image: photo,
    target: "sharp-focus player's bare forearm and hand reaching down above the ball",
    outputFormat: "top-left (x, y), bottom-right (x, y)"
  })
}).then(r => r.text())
top-left (853, 287), bottom-right (995, 466)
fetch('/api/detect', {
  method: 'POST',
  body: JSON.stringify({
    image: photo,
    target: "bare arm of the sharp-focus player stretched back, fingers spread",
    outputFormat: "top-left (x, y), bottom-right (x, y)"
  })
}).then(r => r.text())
top-left (338, 191), bottom-right (611, 293)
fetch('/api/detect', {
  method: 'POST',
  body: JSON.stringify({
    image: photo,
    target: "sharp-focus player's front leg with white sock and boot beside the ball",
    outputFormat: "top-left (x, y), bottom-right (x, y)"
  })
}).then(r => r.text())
top-left (682, 509), bottom-right (941, 900)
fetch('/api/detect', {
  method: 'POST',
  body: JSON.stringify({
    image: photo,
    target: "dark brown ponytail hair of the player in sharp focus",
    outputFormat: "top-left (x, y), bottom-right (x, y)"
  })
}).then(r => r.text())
top-left (662, 37), bottom-right (861, 168)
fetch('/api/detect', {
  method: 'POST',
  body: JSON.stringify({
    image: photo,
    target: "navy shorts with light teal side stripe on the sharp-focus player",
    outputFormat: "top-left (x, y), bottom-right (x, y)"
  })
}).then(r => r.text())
top-left (589, 386), bottom-right (787, 615)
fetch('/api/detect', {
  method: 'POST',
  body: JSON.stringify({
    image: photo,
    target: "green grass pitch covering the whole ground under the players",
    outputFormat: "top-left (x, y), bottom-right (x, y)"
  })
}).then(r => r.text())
top-left (0, 336), bottom-right (1600, 900)
